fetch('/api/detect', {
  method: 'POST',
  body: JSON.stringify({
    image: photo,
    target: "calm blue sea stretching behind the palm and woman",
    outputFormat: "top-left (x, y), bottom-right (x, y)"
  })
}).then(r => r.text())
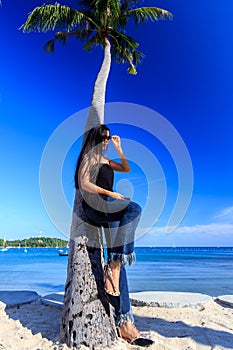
top-left (0, 247), bottom-right (233, 296)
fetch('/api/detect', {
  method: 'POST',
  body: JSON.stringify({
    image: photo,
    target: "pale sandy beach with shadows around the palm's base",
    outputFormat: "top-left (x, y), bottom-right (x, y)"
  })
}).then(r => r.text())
top-left (0, 299), bottom-right (233, 350)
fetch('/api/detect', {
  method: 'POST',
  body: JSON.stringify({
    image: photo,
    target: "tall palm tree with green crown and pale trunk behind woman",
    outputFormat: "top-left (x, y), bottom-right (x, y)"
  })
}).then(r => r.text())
top-left (20, 0), bottom-right (172, 349)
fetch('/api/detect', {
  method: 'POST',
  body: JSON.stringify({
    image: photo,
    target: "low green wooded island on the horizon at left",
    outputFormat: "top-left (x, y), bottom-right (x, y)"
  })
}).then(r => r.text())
top-left (0, 237), bottom-right (68, 248)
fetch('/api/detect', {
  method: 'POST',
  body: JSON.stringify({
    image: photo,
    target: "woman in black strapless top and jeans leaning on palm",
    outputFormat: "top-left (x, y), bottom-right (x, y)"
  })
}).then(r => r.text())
top-left (75, 125), bottom-right (153, 346)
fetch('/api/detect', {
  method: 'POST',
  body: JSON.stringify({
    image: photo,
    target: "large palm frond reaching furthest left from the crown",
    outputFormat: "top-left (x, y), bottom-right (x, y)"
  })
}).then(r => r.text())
top-left (20, 3), bottom-right (94, 32)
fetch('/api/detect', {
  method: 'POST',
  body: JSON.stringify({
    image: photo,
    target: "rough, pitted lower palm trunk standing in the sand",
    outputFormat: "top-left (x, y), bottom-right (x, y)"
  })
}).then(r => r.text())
top-left (61, 190), bottom-right (116, 350)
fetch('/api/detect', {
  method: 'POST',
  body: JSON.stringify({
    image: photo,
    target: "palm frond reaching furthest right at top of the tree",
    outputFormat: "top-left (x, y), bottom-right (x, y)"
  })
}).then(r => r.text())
top-left (127, 7), bottom-right (173, 24)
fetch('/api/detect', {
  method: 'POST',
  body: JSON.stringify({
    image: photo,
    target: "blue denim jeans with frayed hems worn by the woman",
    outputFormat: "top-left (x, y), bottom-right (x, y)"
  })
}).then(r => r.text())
top-left (85, 197), bottom-right (141, 326)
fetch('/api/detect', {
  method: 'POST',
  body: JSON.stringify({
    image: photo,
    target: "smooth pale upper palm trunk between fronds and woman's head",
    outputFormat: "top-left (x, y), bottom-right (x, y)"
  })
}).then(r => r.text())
top-left (85, 38), bottom-right (111, 131)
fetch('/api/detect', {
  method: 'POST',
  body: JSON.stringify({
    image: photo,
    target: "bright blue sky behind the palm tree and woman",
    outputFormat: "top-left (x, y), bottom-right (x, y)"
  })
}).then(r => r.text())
top-left (0, 0), bottom-right (233, 246)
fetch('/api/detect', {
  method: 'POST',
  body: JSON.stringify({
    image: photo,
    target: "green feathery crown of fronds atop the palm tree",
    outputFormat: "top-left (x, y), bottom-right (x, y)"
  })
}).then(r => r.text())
top-left (21, 0), bottom-right (172, 74)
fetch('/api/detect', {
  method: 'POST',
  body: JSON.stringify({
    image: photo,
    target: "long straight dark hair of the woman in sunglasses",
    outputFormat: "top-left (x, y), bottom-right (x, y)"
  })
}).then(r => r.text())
top-left (74, 124), bottom-right (110, 189)
